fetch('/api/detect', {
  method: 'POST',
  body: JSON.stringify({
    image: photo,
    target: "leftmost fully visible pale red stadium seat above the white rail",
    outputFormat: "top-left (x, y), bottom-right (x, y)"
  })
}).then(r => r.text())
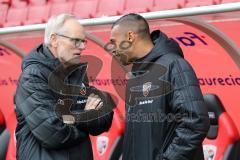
top-left (4, 8), bottom-right (27, 27)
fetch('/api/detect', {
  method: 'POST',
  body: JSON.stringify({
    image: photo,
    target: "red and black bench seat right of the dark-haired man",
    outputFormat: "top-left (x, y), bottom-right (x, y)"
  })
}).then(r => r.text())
top-left (203, 94), bottom-right (240, 160)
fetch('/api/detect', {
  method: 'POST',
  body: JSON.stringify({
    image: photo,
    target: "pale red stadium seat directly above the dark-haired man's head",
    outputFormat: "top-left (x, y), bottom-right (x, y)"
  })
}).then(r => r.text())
top-left (124, 0), bottom-right (153, 13)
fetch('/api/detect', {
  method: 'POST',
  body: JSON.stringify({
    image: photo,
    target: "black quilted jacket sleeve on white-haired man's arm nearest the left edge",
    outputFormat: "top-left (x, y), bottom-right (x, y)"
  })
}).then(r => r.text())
top-left (15, 67), bottom-right (88, 149)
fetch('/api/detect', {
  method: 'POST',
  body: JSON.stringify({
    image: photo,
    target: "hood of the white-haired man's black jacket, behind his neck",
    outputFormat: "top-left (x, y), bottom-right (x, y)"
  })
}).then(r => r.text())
top-left (22, 44), bottom-right (60, 70)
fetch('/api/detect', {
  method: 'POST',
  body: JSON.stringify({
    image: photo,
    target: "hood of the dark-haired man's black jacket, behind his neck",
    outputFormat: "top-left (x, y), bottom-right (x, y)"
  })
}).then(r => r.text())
top-left (136, 30), bottom-right (184, 62)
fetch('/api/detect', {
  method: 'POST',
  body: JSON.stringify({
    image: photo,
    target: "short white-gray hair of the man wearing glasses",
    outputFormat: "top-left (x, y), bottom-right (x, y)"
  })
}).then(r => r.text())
top-left (44, 13), bottom-right (76, 45)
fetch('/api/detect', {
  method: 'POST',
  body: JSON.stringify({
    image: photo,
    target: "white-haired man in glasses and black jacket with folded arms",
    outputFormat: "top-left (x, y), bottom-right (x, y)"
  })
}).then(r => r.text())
top-left (15, 14), bottom-right (113, 160)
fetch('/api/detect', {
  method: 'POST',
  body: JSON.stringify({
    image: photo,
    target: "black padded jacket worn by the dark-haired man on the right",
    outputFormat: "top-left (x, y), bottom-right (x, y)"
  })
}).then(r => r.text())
top-left (123, 31), bottom-right (209, 160)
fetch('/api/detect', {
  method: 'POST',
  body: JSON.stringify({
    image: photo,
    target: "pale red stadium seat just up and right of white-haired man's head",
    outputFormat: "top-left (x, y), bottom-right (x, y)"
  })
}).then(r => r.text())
top-left (73, 0), bottom-right (98, 18)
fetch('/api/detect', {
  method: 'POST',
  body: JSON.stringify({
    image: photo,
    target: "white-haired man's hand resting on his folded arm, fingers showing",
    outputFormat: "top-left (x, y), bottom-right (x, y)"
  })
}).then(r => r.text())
top-left (84, 93), bottom-right (103, 110)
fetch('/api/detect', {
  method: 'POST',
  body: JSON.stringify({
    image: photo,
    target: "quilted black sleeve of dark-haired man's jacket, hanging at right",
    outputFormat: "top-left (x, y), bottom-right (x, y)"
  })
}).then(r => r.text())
top-left (163, 59), bottom-right (209, 160)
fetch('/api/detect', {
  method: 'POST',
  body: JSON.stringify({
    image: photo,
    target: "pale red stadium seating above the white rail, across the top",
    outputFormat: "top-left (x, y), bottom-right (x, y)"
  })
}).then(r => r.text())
top-left (0, 0), bottom-right (240, 27)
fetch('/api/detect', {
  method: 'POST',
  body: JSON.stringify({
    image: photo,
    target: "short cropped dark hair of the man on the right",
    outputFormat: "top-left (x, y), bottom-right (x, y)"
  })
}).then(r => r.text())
top-left (112, 13), bottom-right (150, 38)
